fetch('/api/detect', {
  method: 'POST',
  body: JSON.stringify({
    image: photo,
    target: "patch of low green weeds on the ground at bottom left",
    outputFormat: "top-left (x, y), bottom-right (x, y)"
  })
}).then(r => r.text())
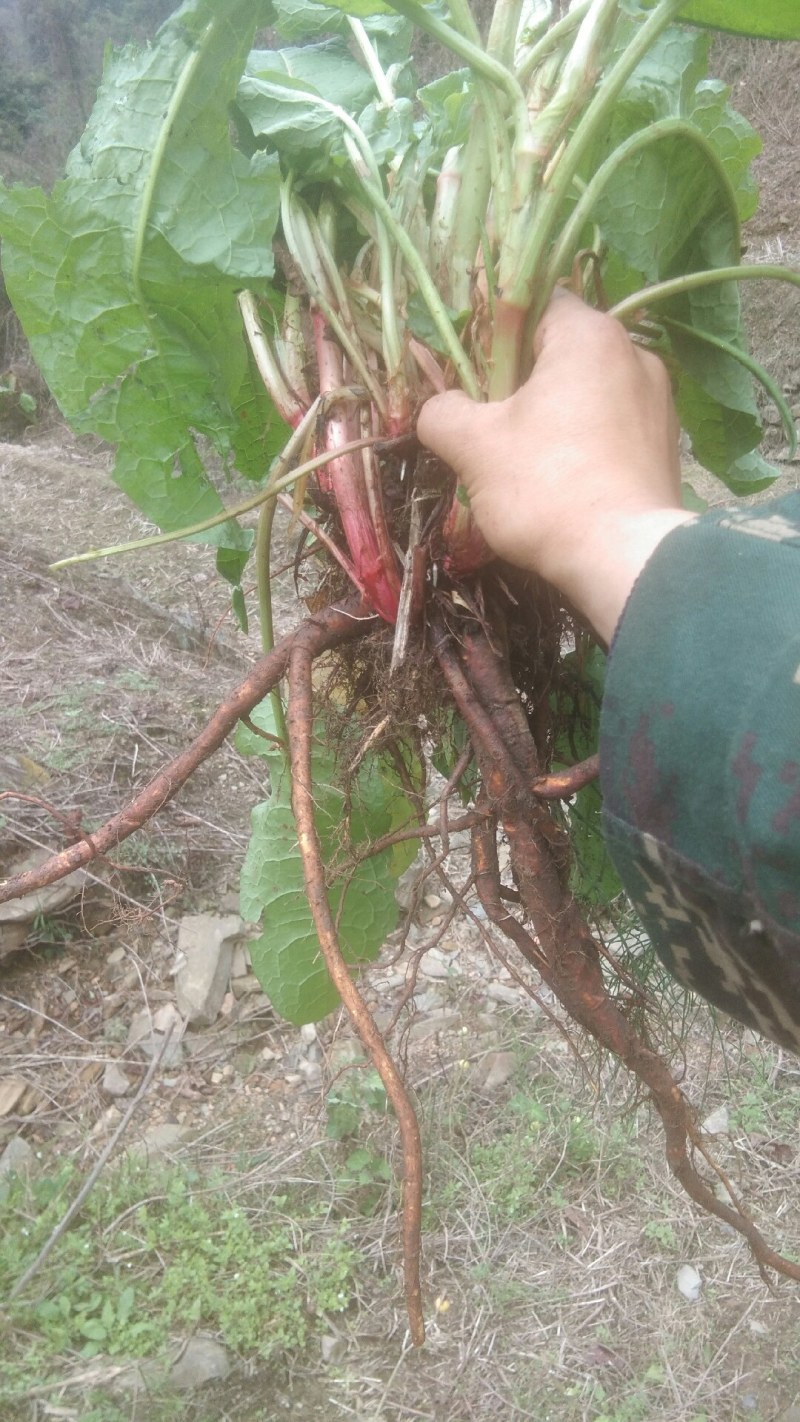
top-left (0, 1162), bottom-right (355, 1389)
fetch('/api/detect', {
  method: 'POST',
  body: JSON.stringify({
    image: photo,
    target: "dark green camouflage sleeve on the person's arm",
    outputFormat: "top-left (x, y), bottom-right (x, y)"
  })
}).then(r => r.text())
top-left (600, 493), bottom-right (800, 1051)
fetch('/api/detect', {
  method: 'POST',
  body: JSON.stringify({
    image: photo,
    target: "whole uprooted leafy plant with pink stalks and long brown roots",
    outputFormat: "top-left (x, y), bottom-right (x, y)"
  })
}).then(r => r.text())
top-left (0, 0), bottom-right (800, 1342)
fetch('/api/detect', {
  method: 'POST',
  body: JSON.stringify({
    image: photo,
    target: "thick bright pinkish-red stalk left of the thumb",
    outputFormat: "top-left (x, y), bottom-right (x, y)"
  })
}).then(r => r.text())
top-left (313, 310), bottom-right (401, 624)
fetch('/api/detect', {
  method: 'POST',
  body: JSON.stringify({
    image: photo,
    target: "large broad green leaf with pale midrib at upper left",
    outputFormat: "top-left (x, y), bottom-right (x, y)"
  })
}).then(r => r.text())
top-left (0, 0), bottom-right (283, 577)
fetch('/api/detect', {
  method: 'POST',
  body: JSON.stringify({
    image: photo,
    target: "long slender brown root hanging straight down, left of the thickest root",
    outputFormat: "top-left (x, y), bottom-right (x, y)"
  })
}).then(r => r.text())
top-left (287, 629), bottom-right (425, 1345)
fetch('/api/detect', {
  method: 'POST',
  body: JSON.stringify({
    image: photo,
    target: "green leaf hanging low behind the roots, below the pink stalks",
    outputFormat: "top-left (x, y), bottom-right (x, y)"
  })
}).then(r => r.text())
top-left (236, 702), bottom-right (416, 1024)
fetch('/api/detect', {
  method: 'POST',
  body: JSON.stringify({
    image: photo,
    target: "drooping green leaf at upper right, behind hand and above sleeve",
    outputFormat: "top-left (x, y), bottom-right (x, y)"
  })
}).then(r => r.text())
top-left (593, 13), bottom-right (766, 488)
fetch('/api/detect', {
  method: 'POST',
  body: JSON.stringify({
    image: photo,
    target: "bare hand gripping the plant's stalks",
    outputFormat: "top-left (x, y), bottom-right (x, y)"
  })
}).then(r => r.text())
top-left (418, 292), bottom-right (695, 641)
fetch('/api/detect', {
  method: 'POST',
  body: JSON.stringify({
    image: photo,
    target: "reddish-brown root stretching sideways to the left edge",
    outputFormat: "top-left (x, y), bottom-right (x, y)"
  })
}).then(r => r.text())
top-left (0, 602), bottom-right (372, 903)
